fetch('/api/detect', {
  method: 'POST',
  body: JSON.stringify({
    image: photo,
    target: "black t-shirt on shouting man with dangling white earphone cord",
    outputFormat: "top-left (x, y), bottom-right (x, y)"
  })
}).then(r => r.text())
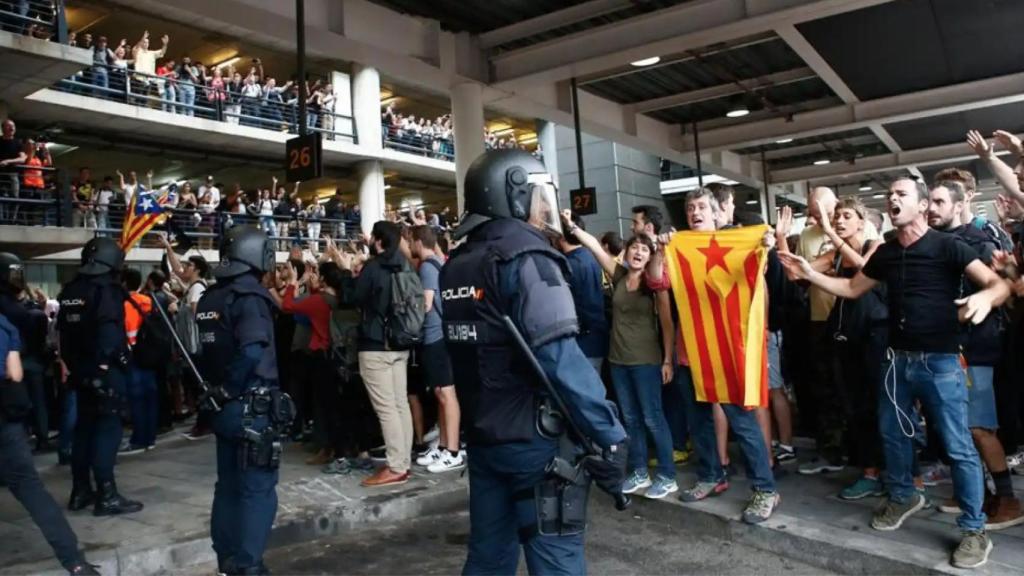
top-left (861, 230), bottom-right (978, 354)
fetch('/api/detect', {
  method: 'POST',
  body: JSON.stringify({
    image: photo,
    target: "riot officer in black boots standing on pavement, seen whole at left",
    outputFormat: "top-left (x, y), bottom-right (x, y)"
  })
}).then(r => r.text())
top-left (57, 238), bottom-right (142, 516)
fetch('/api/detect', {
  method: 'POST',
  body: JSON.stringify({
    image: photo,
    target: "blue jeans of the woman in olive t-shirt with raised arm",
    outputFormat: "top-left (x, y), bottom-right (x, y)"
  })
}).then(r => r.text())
top-left (611, 363), bottom-right (676, 479)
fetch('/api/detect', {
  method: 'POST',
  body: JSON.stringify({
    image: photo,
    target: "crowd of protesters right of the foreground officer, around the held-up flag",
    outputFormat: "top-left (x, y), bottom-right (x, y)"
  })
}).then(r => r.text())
top-left (548, 127), bottom-right (1024, 568)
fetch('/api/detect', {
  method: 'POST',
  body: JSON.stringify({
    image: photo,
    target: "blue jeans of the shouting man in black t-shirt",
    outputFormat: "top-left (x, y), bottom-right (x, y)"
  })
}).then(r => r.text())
top-left (879, 351), bottom-right (985, 530)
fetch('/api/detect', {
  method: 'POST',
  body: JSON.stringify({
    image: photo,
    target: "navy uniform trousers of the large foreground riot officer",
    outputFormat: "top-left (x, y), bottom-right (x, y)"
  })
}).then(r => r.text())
top-left (462, 430), bottom-right (587, 576)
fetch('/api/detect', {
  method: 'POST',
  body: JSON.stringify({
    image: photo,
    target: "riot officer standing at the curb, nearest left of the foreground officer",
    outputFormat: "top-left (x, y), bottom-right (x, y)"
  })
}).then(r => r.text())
top-left (196, 227), bottom-right (294, 574)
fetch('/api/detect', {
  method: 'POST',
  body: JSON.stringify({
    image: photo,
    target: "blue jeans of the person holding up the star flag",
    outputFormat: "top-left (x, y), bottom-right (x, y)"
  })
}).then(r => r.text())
top-left (676, 366), bottom-right (775, 492)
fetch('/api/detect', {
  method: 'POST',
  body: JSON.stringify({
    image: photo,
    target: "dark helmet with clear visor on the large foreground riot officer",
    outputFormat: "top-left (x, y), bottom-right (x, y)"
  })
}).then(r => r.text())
top-left (455, 150), bottom-right (561, 238)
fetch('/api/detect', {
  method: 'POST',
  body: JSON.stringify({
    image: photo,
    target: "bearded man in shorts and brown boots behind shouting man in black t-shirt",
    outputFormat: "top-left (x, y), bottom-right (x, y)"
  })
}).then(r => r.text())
top-left (928, 180), bottom-right (1024, 530)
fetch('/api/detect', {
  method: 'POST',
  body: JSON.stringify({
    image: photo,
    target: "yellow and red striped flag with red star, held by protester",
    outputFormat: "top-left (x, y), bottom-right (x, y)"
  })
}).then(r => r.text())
top-left (666, 225), bottom-right (768, 407)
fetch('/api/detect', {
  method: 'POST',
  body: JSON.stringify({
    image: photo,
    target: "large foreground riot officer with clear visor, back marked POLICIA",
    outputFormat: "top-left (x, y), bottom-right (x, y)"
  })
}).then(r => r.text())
top-left (441, 151), bottom-right (627, 575)
